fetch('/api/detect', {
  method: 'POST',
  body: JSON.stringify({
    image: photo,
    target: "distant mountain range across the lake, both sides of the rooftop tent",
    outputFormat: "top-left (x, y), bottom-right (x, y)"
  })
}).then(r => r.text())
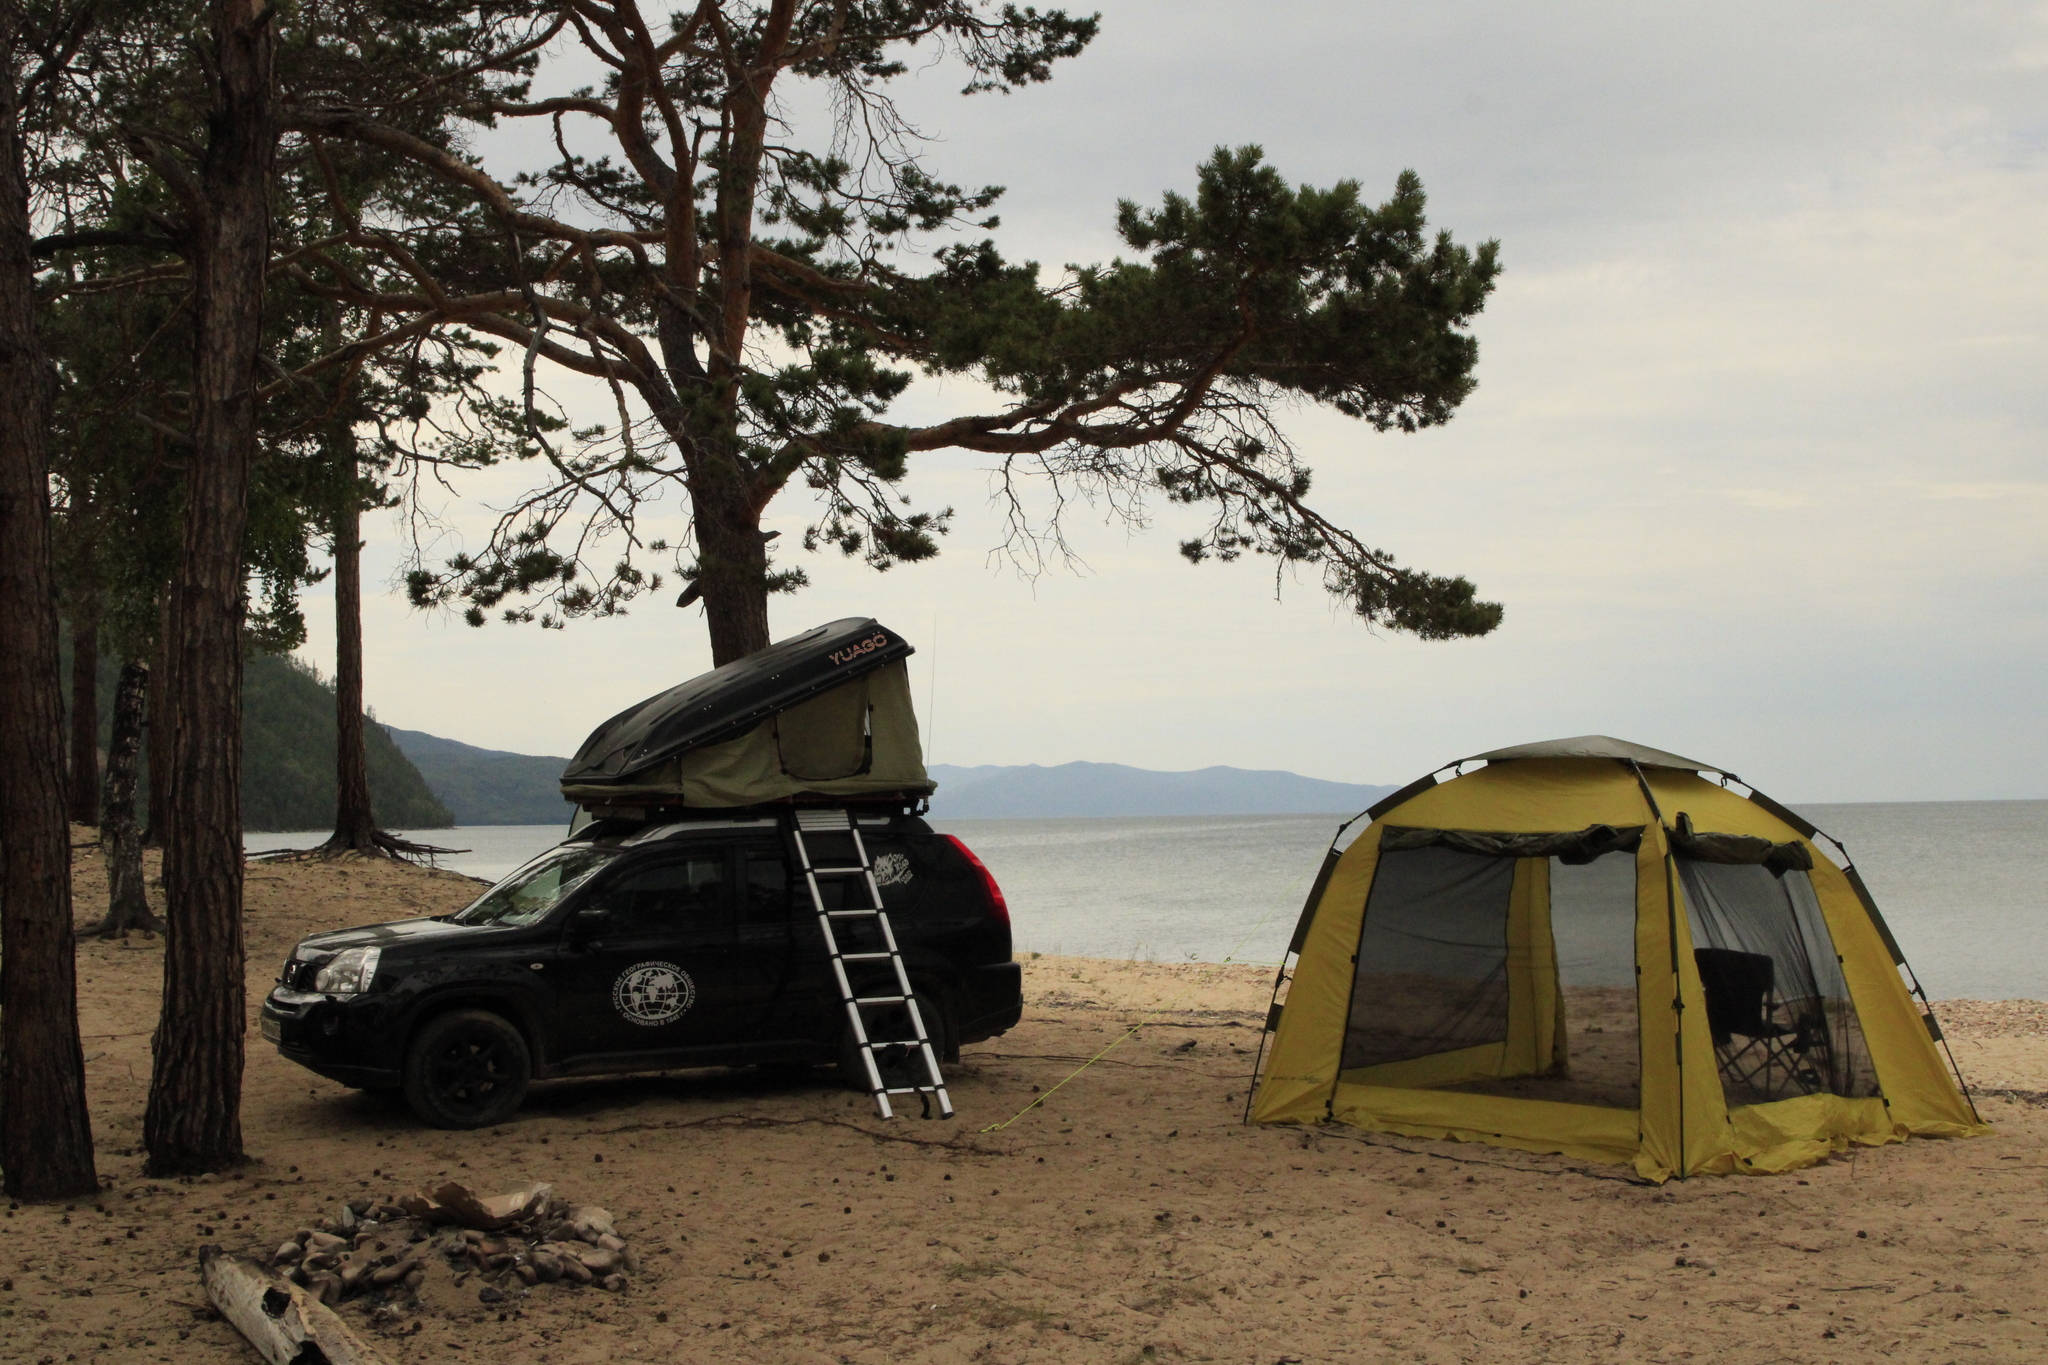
top-left (383, 724), bottom-right (1395, 825)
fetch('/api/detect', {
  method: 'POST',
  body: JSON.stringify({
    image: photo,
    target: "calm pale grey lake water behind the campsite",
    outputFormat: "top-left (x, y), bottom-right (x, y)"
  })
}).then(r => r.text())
top-left (246, 800), bottom-right (2048, 999)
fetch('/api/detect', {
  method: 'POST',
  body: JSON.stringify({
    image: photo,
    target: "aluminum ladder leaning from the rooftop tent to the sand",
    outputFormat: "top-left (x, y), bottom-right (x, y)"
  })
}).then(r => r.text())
top-left (791, 808), bottom-right (952, 1119)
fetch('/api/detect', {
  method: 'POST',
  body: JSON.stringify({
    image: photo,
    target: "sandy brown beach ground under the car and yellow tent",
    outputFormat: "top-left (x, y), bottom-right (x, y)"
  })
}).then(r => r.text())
top-left (0, 835), bottom-right (2048, 1365)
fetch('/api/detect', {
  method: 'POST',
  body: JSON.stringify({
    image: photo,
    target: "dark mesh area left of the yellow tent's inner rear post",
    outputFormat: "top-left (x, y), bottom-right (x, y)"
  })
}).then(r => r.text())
top-left (1343, 847), bottom-right (1516, 1070)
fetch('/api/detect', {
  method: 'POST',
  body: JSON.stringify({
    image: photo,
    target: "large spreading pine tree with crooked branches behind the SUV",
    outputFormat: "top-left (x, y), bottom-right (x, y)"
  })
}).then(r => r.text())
top-left (287, 0), bottom-right (1501, 663)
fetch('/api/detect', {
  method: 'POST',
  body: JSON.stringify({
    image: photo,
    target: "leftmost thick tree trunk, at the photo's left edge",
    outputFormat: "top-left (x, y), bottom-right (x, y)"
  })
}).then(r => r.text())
top-left (0, 35), bottom-right (98, 1199)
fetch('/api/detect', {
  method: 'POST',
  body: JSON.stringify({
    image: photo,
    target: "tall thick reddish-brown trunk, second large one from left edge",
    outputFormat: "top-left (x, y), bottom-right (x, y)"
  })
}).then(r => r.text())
top-left (143, 0), bottom-right (276, 1177)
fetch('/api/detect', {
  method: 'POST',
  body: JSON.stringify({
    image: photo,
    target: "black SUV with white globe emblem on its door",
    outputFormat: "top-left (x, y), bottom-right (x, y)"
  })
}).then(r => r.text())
top-left (262, 808), bottom-right (1022, 1128)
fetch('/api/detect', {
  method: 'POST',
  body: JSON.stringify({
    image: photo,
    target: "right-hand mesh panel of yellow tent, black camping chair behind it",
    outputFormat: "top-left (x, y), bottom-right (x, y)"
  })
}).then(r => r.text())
top-left (1677, 855), bottom-right (1878, 1107)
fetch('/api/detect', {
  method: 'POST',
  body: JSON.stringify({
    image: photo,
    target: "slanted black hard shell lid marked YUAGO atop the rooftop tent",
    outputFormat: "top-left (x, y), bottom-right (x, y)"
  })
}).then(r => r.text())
top-left (561, 616), bottom-right (918, 784)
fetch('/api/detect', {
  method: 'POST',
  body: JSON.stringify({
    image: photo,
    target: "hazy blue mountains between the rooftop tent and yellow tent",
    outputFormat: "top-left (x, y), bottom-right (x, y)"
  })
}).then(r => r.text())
top-left (930, 763), bottom-right (1395, 821)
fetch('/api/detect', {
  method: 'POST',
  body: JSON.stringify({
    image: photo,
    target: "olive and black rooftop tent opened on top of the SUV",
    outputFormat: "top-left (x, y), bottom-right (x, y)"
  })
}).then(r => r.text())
top-left (561, 616), bottom-right (934, 808)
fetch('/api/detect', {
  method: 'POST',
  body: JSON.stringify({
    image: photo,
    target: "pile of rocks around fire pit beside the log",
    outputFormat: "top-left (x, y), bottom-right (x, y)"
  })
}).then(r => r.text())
top-left (270, 1183), bottom-right (641, 1306)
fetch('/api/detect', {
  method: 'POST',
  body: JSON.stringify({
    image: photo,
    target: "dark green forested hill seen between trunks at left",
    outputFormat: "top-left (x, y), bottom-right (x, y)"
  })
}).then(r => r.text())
top-left (63, 655), bottom-right (455, 831)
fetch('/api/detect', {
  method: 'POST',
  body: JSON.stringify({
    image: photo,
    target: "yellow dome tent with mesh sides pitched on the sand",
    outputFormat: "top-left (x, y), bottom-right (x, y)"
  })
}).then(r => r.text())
top-left (1251, 735), bottom-right (1987, 1181)
